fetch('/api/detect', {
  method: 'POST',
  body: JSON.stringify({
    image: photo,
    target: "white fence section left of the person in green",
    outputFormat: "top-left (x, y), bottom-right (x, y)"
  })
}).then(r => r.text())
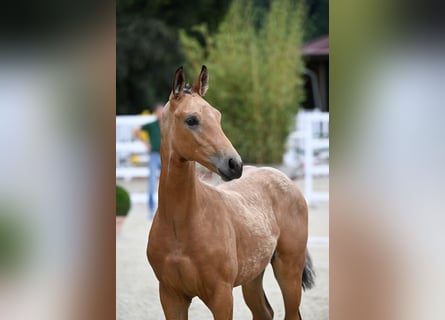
top-left (116, 115), bottom-right (156, 180)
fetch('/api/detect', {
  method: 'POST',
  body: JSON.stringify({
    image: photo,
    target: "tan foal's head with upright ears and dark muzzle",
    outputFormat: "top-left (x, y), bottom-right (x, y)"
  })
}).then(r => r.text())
top-left (161, 66), bottom-right (243, 181)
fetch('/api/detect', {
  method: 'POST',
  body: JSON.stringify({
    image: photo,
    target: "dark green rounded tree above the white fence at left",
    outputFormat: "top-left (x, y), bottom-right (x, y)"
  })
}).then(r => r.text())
top-left (116, 18), bottom-right (182, 114)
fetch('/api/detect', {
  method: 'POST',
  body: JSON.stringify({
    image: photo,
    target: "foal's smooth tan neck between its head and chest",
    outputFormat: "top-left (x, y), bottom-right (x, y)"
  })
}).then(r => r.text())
top-left (158, 148), bottom-right (199, 220)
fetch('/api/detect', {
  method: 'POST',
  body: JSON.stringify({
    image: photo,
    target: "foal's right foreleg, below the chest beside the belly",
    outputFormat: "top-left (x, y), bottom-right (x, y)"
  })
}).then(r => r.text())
top-left (201, 284), bottom-right (233, 320)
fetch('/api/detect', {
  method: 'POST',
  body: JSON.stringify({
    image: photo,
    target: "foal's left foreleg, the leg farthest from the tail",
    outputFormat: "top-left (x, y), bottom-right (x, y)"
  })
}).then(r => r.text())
top-left (159, 284), bottom-right (191, 320)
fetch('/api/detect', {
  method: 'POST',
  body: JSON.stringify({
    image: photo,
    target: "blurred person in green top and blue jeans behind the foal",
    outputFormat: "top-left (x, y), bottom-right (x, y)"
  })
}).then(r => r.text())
top-left (134, 103), bottom-right (164, 219)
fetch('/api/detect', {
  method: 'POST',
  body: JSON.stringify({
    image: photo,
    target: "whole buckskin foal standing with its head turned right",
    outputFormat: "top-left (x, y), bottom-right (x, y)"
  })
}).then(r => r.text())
top-left (147, 66), bottom-right (313, 320)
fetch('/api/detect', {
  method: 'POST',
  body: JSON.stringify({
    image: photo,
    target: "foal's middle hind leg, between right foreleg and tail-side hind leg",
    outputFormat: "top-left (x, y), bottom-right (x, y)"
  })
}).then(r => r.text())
top-left (242, 271), bottom-right (273, 320)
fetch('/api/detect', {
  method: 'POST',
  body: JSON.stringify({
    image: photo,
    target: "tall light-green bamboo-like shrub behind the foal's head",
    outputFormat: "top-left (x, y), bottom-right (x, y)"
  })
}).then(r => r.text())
top-left (180, 0), bottom-right (304, 163)
